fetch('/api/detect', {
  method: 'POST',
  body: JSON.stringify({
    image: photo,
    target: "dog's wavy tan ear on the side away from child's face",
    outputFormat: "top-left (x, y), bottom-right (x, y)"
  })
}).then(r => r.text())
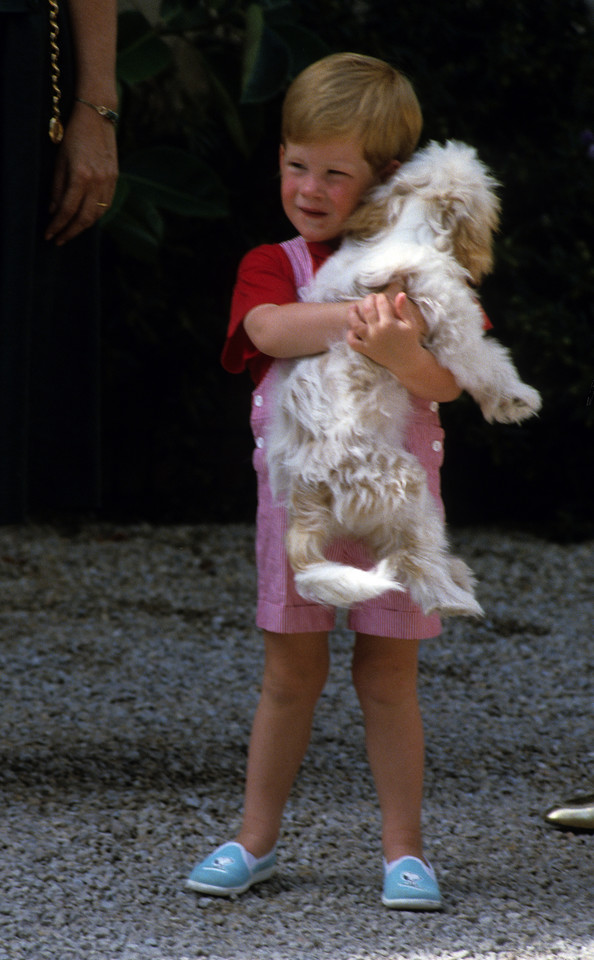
top-left (443, 191), bottom-right (499, 284)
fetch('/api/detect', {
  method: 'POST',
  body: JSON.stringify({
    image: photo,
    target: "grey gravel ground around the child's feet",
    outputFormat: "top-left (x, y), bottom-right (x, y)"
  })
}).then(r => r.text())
top-left (0, 524), bottom-right (594, 960)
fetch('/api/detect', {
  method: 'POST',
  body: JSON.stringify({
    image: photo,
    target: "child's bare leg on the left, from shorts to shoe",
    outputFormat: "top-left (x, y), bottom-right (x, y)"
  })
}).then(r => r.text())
top-left (237, 631), bottom-right (329, 857)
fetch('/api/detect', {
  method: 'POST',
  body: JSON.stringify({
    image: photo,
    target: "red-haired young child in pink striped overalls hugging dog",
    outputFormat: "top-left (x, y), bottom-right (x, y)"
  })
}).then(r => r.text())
top-left (187, 53), bottom-right (460, 910)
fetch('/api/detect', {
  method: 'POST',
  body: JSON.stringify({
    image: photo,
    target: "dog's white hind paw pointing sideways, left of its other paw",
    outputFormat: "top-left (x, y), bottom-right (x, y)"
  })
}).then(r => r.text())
top-left (295, 560), bottom-right (406, 607)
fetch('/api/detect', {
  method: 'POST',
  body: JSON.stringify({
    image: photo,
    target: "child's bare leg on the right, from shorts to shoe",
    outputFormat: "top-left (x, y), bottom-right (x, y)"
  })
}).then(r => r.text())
top-left (353, 634), bottom-right (424, 863)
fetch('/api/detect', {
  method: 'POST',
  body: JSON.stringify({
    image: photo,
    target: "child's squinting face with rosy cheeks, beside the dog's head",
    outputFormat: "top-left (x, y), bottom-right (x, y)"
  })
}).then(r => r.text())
top-left (280, 139), bottom-right (376, 242)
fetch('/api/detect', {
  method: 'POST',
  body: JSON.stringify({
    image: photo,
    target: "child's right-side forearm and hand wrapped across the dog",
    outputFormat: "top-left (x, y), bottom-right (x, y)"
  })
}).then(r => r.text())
top-left (347, 293), bottom-right (462, 403)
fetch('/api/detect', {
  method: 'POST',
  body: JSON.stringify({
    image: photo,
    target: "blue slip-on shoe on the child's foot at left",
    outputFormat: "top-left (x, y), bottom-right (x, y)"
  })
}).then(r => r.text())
top-left (186, 841), bottom-right (276, 897)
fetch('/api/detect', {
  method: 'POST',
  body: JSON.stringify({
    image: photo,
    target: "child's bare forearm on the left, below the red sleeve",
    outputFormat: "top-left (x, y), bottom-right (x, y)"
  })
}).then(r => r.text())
top-left (243, 302), bottom-right (351, 357)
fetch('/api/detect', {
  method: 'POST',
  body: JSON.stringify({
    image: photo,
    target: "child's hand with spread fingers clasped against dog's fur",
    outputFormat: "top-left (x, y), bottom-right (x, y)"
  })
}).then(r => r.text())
top-left (347, 290), bottom-right (427, 377)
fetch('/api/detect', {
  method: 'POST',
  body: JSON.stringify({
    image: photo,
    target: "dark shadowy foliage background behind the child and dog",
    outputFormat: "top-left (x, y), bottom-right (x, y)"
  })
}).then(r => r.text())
top-left (99, 0), bottom-right (594, 536)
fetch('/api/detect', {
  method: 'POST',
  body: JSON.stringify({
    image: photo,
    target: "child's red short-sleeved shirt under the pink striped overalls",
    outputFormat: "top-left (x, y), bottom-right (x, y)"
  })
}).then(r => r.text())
top-left (221, 243), bottom-right (336, 384)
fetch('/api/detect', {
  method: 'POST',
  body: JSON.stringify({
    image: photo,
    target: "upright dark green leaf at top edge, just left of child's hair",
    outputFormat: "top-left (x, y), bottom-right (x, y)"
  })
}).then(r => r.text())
top-left (241, 4), bottom-right (289, 103)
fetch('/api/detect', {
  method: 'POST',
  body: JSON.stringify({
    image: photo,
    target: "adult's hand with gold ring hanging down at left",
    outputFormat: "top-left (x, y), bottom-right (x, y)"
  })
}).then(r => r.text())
top-left (45, 103), bottom-right (118, 246)
